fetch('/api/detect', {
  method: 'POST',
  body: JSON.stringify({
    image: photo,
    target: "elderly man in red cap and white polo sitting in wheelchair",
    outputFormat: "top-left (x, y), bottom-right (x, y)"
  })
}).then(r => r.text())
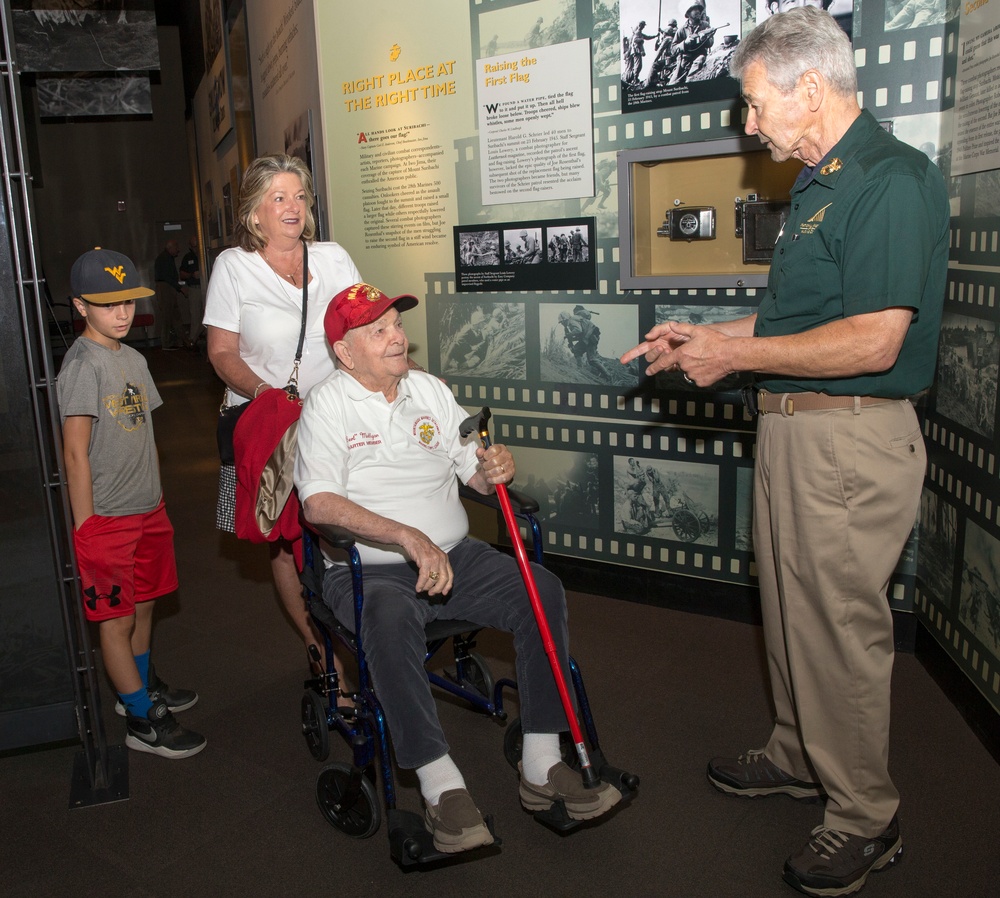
top-left (295, 284), bottom-right (622, 853)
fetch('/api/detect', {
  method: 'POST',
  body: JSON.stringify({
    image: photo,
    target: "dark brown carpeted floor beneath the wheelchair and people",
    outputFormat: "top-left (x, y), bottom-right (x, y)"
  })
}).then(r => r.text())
top-left (0, 350), bottom-right (1000, 898)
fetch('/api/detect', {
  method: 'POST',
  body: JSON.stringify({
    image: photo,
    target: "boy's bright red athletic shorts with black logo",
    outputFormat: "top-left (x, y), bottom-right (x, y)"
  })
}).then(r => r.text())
top-left (73, 500), bottom-right (177, 621)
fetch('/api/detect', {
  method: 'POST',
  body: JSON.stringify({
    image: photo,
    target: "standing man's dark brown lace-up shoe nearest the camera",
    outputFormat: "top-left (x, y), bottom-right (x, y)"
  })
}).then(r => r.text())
top-left (784, 817), bottom-right (903, 896)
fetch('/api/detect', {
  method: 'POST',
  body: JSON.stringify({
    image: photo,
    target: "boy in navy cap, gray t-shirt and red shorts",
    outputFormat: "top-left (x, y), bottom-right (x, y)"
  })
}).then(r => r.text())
top-left (57, 247), bottom-right (206, 758)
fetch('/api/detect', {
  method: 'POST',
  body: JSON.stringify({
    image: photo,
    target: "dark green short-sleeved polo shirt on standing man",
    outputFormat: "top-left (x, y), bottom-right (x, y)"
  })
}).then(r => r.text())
top-left (754, 110), bottom-right (950, 398)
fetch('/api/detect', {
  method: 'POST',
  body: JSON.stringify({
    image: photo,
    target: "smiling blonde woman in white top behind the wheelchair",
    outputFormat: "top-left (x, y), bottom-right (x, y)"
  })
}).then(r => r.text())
top-left (204, 155), bottom-right (361, 670)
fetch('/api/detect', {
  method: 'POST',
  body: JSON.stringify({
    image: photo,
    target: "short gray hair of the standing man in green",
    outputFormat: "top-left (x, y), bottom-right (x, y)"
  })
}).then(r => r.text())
top-left (729, 6), bottom-right (858, 97)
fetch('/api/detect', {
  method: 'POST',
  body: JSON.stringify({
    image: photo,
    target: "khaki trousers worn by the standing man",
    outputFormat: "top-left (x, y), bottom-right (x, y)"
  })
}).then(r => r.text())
top-left (753, 400), bottom-right (926, 837)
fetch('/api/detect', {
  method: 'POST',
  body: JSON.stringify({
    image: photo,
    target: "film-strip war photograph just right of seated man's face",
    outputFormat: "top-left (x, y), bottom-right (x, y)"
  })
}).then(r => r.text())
top-left (438, 302), bottom-right (526, 381)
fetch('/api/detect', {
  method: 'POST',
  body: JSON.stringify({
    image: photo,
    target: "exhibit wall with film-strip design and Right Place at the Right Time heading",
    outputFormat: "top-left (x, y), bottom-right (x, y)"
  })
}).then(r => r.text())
top-left (282, 0), bottom-right (1000, 710)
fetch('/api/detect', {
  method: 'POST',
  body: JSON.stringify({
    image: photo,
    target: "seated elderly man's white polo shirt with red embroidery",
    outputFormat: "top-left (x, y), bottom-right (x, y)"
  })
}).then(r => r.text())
top-left (295, 371), bottom-right (478, 564)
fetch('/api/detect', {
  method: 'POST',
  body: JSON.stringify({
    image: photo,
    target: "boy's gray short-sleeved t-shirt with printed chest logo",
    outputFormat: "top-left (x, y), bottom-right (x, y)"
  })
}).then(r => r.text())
top-left (56, 337), bottom-right (163, 517)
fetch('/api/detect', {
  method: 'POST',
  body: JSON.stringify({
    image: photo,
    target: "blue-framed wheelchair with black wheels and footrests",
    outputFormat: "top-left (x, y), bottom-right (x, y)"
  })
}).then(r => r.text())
top-left (300, 486), bottom-right (639, 869)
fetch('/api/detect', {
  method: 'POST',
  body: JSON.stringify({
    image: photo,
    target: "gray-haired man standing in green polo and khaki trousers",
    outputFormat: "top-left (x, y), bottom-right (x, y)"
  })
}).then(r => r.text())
top-left (622, 7), bottom-right (949, 895)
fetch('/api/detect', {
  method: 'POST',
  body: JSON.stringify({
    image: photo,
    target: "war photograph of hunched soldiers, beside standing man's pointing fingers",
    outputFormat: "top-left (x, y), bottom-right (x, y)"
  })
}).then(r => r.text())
top-left (538, 302), bottom-right (639, 387)
